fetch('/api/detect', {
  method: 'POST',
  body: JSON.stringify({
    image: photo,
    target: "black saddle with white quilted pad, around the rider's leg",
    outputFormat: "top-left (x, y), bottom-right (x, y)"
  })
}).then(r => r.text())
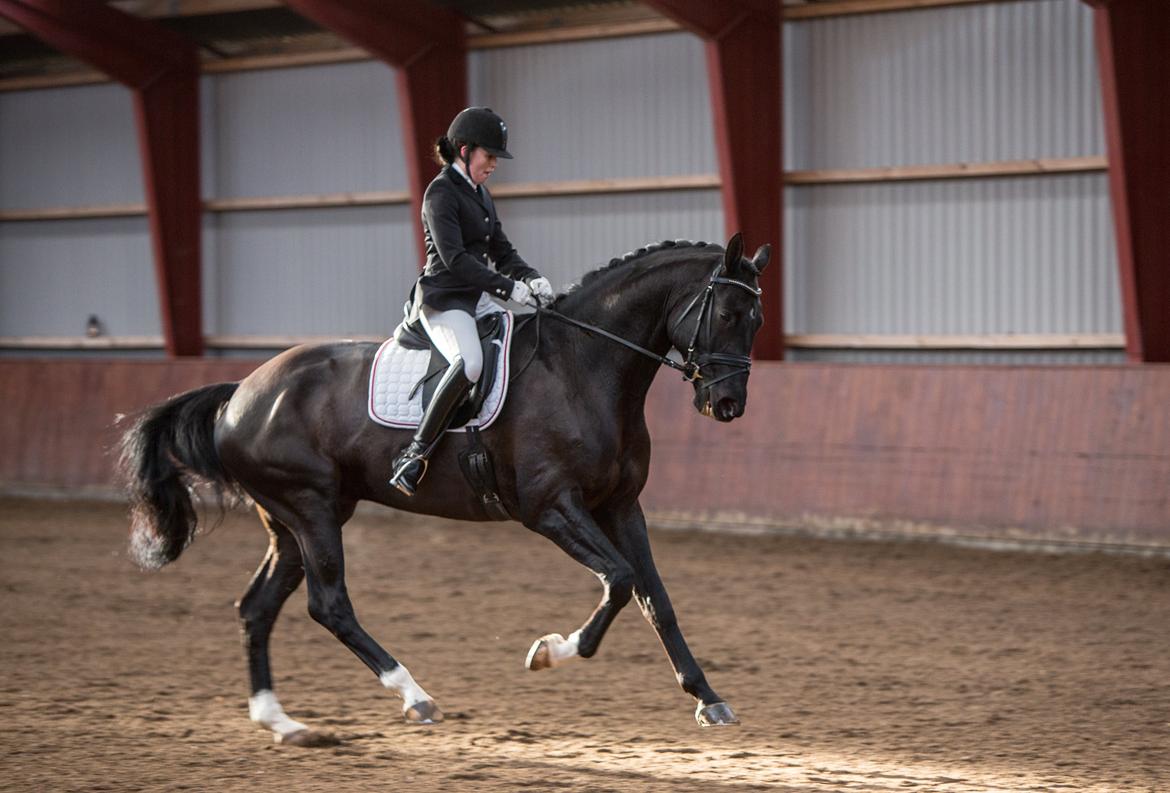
top-left (370, 311), bottom-right (514, 432)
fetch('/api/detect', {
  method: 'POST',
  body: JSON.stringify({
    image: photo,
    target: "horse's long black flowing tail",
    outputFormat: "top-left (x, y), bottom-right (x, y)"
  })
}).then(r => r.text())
top-left (118, 382), bottom-right (240, 570)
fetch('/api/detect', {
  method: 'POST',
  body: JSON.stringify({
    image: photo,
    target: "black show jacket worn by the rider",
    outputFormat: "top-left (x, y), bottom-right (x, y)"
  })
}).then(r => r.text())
top-left (419, 165), bottom-right (539, 315)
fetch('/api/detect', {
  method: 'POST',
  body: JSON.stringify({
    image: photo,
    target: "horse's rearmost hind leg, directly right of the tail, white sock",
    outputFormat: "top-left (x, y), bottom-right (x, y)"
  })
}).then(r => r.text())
top-left (238, 508), bottom-right (312, 744)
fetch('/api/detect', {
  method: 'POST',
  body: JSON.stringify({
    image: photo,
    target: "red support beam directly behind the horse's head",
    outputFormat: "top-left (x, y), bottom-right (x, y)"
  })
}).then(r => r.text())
top-left (646, 0), bottom-right (784, 360)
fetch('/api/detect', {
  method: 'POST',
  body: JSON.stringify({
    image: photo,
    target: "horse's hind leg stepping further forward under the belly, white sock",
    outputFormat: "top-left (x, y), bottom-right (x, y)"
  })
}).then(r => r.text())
top-left (269, 494), bottom-right (442, 724)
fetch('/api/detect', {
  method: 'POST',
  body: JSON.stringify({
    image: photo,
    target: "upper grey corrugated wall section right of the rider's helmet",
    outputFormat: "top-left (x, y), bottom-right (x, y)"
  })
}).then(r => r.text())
top-left (469, 34), bottom-right (718, 181)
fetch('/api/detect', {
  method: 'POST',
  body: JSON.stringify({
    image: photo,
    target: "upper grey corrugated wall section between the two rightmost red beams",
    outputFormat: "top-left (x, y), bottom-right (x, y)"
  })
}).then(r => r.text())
top-left (785, 0), bottom-right (1104, 170)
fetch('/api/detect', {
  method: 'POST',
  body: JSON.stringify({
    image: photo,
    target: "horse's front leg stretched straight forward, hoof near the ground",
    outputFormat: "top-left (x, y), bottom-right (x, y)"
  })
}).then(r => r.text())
top-left (601, 502), bottom-right (739, 726)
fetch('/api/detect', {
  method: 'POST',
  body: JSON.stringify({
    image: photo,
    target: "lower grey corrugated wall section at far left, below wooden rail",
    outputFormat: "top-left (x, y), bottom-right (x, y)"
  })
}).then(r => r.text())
top-left (0, 218), bottom-right (163, 337)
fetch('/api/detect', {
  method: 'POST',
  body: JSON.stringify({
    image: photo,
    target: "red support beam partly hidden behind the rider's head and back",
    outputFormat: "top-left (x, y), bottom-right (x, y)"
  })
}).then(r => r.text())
top-left (284, 0), bottom-right (467, 260)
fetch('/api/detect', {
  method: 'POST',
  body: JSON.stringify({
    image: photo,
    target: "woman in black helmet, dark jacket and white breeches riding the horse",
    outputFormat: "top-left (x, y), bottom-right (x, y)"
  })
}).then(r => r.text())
top-left (390, 108), bottom-right (553, 496)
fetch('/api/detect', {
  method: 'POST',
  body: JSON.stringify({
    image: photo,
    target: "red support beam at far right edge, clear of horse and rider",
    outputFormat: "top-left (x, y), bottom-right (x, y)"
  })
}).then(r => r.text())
top-left (1086, 0), bottom-right (1170, 363)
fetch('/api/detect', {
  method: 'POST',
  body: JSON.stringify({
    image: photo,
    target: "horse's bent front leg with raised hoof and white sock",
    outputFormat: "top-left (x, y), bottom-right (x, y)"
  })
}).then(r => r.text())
top-left (524, 492), bottom-right (634, 670)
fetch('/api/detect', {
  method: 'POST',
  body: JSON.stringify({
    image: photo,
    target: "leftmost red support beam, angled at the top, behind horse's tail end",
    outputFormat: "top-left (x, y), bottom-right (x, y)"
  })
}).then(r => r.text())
top-left (0, 0), bottom-right (204, 356)
